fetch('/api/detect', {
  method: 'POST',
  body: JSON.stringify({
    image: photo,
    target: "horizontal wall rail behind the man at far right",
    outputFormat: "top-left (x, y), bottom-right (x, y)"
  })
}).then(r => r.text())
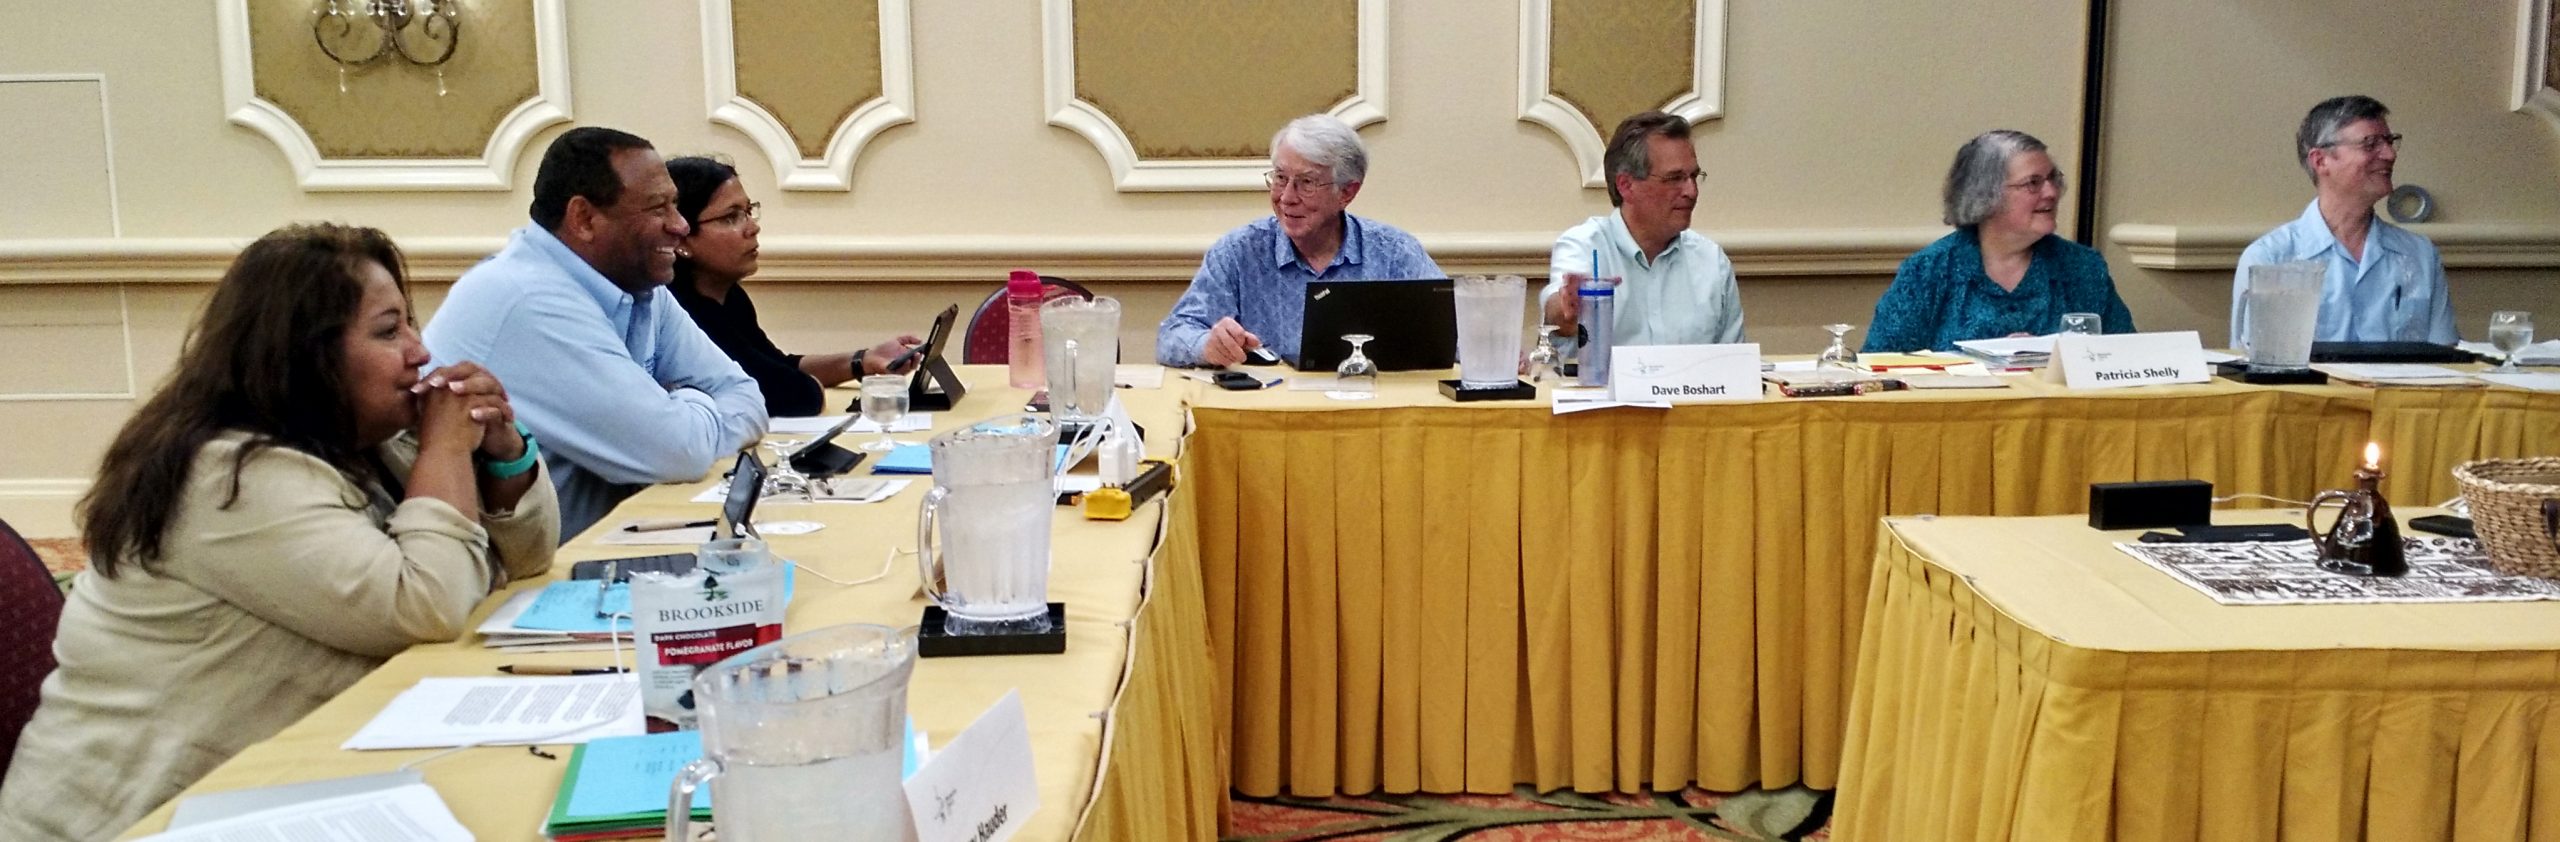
top-left (2107, 223), bottom-right (2560, 271)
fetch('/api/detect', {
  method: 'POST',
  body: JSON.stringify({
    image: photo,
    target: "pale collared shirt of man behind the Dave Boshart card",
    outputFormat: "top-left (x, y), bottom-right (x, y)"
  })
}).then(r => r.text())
top-left (1539, 210), bottom-right (1743, 348)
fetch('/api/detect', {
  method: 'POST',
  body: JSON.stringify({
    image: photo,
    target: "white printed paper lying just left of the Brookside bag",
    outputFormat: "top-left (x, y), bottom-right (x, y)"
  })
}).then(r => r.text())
top-left (338, 673), bottom-right (645, 752)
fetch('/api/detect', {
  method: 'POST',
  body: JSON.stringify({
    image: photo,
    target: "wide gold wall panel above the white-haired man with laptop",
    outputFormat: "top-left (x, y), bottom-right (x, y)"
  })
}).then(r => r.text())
top-left (1075, 0), bottom-right (1359, 159)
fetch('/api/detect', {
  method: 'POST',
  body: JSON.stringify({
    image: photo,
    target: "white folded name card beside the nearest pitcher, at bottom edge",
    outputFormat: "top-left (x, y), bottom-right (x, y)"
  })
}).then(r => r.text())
top-left (906, 691), bottom-right (1039, 842)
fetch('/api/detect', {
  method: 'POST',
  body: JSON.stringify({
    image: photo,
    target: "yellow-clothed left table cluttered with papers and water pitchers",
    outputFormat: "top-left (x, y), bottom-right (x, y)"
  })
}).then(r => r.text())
top-left (128, 366), bottom-right (1226, 839)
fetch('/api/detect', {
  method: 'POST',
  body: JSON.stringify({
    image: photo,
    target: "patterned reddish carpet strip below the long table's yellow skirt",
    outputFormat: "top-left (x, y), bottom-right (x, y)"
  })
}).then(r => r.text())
top-left (1226, 786), bottom-right (1830, 842)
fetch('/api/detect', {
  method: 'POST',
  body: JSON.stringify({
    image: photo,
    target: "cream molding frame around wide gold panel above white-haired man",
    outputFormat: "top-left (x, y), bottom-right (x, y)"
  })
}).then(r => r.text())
top-left (1039, 0), bottom-right (1388, 192)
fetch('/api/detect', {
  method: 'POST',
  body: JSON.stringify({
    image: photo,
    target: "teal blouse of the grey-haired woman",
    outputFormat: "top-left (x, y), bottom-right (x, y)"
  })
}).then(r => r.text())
top-left (1859, 225), bottom-right (2135, 353)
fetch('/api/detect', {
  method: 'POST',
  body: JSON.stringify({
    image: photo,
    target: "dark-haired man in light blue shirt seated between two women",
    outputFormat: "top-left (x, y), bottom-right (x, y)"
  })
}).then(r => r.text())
top-left (425, 128), bottom-right (765, 540)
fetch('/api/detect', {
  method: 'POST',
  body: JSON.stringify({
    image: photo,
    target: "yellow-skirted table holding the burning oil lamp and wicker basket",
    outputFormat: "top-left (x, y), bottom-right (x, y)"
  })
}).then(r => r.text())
top-left (1833, 520), bottom-right (2560, 842)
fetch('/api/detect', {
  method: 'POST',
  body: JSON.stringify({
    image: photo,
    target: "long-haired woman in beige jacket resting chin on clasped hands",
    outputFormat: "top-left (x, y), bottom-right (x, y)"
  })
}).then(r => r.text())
top-left (0, 225), bottom-right (561, 839)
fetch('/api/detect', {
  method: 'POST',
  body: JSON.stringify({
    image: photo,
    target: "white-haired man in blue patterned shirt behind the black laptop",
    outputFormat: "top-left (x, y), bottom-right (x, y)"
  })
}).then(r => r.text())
top-left (1155, 115), bottom-right (1441, 366)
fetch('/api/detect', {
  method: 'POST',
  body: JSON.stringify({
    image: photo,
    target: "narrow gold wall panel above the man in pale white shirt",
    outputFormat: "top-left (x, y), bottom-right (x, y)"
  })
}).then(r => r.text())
top-left (1546, 0), bottom-right (1697, 134)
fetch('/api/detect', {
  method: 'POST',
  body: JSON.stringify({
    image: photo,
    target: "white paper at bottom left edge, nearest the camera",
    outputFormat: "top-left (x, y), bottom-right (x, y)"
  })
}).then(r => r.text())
top-left (143, 783), bottom-right (471, 842)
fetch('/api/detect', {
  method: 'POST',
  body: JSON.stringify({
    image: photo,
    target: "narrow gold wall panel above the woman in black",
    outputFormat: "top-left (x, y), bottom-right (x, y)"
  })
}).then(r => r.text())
top-left (730, 0), bottom-right (881, 159)
